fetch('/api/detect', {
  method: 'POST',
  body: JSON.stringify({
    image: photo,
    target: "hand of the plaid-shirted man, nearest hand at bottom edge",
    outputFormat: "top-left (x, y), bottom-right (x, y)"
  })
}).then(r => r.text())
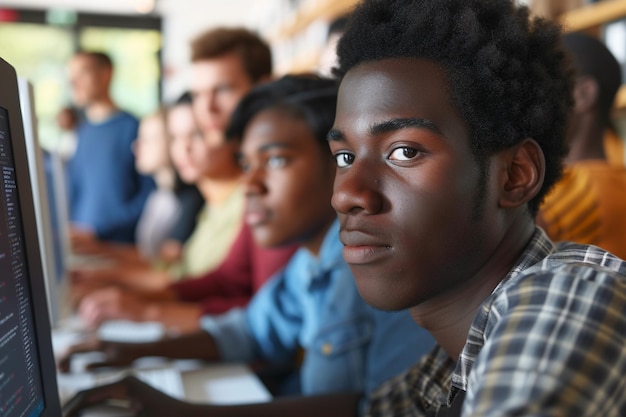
top-left (63, 376), bottom-right (192, 417)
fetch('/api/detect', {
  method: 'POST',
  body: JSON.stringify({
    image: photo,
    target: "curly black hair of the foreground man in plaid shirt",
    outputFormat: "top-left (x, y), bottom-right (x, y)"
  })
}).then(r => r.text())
top-left (333, 0), bottom-right (573, 216)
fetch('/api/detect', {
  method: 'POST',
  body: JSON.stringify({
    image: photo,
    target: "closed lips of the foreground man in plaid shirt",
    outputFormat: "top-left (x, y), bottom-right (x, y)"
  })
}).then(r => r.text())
top-left (339, 230), bottom-right (392, 265)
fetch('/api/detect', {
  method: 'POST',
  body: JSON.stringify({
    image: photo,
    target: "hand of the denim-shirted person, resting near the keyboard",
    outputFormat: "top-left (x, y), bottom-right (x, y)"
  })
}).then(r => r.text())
top-left (57, 338), bottom-right (146, 372)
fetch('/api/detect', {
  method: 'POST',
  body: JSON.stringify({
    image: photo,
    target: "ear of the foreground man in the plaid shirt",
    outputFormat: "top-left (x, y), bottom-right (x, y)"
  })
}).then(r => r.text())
top-left (498, 139), bottom-right (545, 208)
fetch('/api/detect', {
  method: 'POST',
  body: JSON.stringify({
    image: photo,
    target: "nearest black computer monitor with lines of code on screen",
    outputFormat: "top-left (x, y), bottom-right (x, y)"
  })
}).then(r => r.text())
top-left (0, 59), bottom-right (61, 417)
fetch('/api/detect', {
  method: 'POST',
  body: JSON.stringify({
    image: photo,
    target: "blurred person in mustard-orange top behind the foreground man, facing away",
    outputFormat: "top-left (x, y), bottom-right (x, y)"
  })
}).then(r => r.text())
top-left (537, 33), bottom-right (626, 259)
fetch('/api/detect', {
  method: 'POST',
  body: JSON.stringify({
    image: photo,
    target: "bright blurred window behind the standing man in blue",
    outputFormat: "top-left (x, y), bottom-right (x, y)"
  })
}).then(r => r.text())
top-left (0, 9), bottom-right (162, 149)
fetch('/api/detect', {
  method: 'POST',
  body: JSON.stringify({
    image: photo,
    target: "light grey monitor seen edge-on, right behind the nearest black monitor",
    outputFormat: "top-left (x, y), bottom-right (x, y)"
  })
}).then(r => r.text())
top-left (17, 77), bottom-right (65, 327)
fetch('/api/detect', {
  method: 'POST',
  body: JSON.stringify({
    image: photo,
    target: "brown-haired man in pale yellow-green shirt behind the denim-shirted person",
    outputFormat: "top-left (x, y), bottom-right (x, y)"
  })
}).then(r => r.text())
top-left (162, 27), bottom-right (272, 279)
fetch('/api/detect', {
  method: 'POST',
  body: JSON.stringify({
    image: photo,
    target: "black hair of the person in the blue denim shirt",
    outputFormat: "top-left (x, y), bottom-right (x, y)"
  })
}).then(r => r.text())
top-left (226, 74), bottom-right (338, 152)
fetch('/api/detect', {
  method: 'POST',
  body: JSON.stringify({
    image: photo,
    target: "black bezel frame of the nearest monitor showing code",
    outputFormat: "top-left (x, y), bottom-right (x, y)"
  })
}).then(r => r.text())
top-left (0, 58), bottom-right (61, 417)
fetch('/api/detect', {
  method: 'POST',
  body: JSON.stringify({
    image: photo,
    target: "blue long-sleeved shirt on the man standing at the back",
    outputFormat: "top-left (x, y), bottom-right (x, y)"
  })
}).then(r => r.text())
top-left (68, 112), bottom-right (155, 243)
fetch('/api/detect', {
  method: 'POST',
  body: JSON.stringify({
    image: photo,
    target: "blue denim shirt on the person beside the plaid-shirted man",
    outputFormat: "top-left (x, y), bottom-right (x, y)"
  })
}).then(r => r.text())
top-left (201, 221), bottom-right (434, 395)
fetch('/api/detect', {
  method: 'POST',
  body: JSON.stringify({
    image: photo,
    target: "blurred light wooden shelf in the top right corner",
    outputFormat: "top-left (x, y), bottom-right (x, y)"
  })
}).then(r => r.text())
top-left (560, 0), bottom-right (626, 32)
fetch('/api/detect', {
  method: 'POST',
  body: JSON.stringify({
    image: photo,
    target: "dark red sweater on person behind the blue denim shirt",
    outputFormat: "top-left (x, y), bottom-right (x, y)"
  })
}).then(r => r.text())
top-left (170, 225), bottom-right (298, 314)
